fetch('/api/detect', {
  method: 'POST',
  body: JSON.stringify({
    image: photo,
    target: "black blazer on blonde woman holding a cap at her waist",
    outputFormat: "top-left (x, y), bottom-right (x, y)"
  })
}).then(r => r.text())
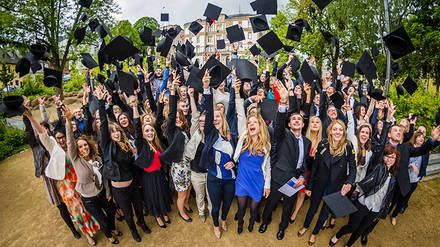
top-left (306, 139), bottom-right (356, 200)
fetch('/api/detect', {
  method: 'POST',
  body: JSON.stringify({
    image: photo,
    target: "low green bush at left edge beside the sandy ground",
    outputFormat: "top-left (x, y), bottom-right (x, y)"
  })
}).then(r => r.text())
top-left (0, 118), bottom-right (28, 160)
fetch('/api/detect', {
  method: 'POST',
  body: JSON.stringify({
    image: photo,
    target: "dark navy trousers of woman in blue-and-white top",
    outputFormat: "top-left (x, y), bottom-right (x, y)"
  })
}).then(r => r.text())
top-left (206, 173), bottom-right (235, 227)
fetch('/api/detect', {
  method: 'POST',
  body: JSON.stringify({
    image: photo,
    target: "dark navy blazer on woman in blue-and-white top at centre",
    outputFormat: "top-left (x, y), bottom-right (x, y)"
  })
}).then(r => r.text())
top-left (200, 92), bottom-right (237, 170)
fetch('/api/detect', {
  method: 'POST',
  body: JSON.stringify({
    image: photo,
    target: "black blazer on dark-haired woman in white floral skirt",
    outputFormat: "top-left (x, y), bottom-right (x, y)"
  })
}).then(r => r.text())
top-left (159, 95), bottom-right (189, 163)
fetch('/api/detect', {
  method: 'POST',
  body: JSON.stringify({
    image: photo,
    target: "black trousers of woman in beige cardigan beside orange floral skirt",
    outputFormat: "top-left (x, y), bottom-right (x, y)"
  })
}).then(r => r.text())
top-left (81, 190), bottom-right (116, 238)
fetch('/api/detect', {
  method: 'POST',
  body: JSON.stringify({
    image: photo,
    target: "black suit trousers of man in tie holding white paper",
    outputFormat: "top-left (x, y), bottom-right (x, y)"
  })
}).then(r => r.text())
top-left (263, 183), bottom-right (298, 229)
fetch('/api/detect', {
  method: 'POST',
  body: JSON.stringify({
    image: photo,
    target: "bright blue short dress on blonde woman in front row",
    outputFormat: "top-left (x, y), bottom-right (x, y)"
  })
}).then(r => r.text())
top-left (235, 150), bottom-right (264, 202)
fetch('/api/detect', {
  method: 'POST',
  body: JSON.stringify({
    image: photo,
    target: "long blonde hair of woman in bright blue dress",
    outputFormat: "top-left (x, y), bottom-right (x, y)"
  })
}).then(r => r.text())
top-left (241, 114), bottom-right (270, 156)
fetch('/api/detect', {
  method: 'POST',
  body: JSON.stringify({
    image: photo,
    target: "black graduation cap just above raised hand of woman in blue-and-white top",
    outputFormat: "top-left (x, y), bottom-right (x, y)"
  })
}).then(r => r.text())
top-left (198, 54), bottom-right (231, 88)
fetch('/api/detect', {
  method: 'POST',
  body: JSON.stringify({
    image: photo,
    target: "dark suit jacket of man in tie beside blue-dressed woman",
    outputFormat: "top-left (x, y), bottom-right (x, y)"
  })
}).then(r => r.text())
top-left (271, 109), bottom-right (312, 187)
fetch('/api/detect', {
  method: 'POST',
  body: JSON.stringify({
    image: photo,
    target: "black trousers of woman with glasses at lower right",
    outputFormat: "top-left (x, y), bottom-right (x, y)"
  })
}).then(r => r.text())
top-left (336, 201), bottom-right (378, 246)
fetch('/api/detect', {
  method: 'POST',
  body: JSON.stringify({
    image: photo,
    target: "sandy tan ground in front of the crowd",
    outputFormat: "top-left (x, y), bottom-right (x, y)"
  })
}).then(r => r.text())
top-left (0, 150), bottom-right (440, 247)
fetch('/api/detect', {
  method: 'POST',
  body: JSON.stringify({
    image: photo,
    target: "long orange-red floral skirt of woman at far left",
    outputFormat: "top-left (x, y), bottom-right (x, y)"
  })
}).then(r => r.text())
top-left (57, 162), bottom-right (99, 237)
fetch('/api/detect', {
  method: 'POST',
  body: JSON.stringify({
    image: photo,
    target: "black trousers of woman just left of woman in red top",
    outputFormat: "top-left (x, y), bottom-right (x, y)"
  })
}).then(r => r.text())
top-left (112, 183), bottom-right (145, 231)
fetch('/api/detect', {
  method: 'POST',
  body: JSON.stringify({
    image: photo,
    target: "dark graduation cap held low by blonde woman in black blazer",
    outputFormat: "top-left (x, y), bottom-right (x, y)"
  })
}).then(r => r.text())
top-left (322, 191), bottom-right (358, 218)
